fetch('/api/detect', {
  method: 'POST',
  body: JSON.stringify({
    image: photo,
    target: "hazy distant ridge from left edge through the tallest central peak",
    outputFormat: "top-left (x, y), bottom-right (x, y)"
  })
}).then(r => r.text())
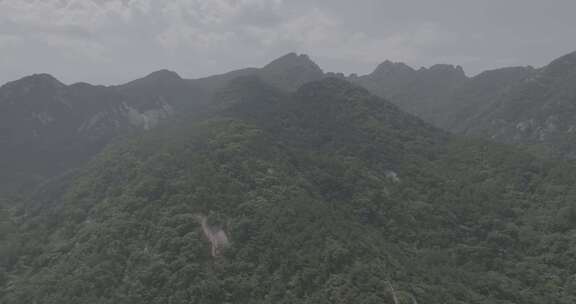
top-left (0, 53), bottom-right (323, 193)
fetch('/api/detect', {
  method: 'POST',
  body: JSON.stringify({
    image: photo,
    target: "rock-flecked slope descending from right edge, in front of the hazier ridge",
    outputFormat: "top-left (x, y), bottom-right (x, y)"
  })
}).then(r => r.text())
top-left (460, 52), bottom-right (576, 158)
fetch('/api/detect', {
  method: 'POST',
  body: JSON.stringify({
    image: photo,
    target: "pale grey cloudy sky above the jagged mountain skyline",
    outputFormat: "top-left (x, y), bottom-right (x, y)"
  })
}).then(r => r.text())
top-left (0, 0), bottom-right (576, 84)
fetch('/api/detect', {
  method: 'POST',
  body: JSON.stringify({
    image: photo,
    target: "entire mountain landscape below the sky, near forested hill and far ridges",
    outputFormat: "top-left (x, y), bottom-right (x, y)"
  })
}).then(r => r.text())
top-left (0, 47), bottom-right (576, 304)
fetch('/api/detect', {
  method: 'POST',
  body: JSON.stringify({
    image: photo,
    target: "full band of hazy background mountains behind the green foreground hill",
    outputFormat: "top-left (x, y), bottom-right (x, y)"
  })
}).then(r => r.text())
top-left (0, 49), bottom-right (576, 189)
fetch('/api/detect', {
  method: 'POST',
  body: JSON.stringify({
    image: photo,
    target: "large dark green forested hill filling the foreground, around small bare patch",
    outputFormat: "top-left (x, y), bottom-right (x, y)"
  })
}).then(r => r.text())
top-left (0, 77), bottom-right (576, 304)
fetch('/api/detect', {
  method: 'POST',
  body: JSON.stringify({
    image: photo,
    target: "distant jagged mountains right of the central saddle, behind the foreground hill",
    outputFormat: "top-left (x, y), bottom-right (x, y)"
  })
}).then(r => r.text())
top-left (347, 52), bottom-right (576, 159)
